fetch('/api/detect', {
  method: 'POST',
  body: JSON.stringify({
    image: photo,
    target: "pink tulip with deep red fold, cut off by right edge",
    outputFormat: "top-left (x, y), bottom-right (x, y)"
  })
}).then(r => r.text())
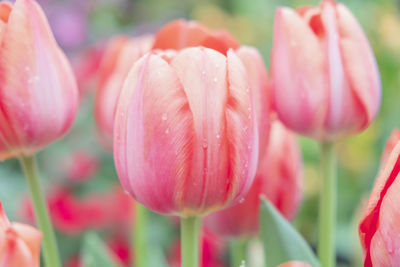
top-left (359, 133), bottom-right (400, 267)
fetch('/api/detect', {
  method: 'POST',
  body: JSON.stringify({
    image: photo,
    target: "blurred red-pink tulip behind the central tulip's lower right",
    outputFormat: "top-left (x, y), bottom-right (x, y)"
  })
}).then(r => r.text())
top-left (206, 121), bottom-right (303, 237)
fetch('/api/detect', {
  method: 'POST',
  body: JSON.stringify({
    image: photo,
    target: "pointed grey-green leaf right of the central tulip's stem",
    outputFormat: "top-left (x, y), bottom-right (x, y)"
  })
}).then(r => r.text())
top-left (260, 199), bottom-right (320, 267)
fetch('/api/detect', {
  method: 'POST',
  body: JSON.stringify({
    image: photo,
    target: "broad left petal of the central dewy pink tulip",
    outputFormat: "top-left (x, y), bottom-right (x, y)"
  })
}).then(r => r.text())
top-left (114, 55), bottom-right (195, 213)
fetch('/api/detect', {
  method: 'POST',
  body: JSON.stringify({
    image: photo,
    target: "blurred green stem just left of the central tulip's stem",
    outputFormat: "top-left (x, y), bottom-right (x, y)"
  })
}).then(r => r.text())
top-left (131, 202), bottom-right (149, 267)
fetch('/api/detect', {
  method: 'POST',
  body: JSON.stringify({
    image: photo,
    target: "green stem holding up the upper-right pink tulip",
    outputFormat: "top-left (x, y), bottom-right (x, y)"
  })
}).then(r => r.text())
top-left (318, 142), bottom-right (337, 267)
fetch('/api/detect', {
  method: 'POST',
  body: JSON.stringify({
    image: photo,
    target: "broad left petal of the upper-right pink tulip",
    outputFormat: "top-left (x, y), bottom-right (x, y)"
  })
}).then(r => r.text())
top-left (271, 8), bottom-right (328, 136)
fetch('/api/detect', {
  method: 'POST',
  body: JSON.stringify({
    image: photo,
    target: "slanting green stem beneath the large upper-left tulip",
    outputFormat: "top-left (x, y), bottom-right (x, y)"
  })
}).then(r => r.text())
top-left (19, 156), bottom-right (61, 267)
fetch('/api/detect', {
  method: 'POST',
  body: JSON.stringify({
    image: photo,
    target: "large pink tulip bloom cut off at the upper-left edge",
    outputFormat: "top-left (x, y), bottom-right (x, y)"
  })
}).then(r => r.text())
top-left (0, 0), bottom-right (78, 160)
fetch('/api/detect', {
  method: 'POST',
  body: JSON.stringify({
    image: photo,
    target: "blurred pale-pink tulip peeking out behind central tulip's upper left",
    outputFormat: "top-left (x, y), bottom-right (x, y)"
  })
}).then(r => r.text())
top-left (94, 36), bottom-right (153, 149)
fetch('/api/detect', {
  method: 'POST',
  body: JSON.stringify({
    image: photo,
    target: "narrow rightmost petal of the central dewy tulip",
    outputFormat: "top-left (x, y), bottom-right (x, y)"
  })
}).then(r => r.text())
top-left (225, 49), bottom-right (259, 204)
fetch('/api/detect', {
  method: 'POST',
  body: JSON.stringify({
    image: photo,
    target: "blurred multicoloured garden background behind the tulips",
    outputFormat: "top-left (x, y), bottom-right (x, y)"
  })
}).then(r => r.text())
top-left (0, 0), bottom-right (400, 267)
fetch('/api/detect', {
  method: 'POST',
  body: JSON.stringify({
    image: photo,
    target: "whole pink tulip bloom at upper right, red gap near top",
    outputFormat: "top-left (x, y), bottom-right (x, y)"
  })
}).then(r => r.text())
top-left (271, 0), bottom-right (381, 141)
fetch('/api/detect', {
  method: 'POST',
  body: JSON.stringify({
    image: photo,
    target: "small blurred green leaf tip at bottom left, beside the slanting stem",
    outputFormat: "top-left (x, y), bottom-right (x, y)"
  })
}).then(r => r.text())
top-left (82, 232), bottom-right (121, 267)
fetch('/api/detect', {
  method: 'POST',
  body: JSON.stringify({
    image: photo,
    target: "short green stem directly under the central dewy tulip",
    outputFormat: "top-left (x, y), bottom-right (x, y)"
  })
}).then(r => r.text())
top-left (181, 217), bottom-right (201, 267)
